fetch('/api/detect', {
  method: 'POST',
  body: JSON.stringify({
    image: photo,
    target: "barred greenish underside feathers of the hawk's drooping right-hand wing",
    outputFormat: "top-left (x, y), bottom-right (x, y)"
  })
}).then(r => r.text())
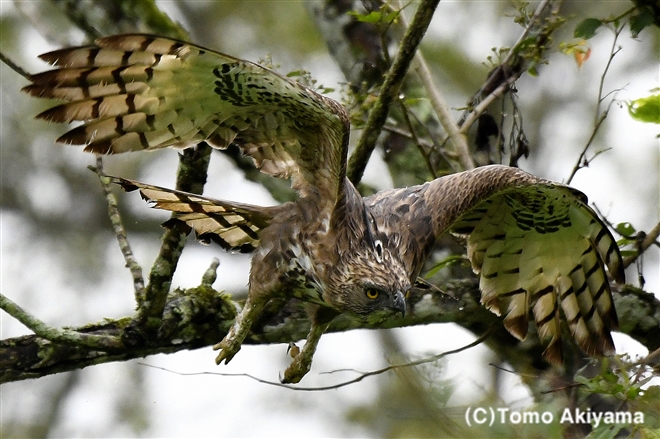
top-left (453, 184), bottom-right (623, 364)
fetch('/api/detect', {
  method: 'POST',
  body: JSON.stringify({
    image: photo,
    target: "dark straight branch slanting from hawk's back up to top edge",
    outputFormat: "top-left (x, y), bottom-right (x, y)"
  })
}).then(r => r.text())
top-left (346, 0), bottom-right (440, 184)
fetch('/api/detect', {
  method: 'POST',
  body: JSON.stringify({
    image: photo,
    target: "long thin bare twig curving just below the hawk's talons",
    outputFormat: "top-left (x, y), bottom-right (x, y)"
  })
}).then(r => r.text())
top-left (139, 331), bottom-right (490, 392)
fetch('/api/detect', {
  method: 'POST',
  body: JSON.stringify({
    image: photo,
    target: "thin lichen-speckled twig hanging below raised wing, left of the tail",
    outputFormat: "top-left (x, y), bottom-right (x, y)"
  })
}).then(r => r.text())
top-left (90, 155), bottom-right (145, 306)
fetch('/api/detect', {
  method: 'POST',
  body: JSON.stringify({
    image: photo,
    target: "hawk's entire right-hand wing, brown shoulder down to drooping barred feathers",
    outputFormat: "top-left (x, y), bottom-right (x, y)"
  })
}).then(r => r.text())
top-left (367, 166), bottom-right (624, 363)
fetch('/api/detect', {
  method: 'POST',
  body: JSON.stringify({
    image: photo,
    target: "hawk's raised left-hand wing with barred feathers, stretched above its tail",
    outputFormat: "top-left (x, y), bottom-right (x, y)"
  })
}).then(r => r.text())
top-left (24, 35), bottom-right (349, 201)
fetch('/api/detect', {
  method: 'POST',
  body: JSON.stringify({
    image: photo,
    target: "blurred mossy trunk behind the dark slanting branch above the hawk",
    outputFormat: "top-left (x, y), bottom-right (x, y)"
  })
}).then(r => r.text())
top-left (306, 0), bottom-right (458, 186)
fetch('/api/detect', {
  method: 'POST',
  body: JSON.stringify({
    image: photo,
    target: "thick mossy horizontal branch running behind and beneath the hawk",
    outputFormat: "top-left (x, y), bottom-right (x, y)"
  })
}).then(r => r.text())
top-left (0, 278), bottom-right (660, 383)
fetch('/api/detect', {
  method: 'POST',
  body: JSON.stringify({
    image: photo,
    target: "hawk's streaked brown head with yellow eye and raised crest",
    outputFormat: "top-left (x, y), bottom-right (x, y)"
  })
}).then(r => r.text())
top-left (323, 200), bottom-right (411, 323)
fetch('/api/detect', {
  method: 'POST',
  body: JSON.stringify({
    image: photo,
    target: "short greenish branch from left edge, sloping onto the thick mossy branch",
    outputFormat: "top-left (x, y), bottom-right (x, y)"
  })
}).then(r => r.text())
top-left (0, 294), bottom-right (124, 350)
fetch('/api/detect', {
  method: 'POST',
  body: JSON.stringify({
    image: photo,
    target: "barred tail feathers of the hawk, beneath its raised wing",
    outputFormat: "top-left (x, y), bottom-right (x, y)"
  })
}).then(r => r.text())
top-left (111, 177), bottom-right (281, 253)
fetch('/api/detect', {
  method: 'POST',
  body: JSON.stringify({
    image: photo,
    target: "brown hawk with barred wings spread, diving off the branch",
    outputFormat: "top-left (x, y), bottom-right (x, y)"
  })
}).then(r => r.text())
top-left (24, 34), bottom-right (624, 382)
